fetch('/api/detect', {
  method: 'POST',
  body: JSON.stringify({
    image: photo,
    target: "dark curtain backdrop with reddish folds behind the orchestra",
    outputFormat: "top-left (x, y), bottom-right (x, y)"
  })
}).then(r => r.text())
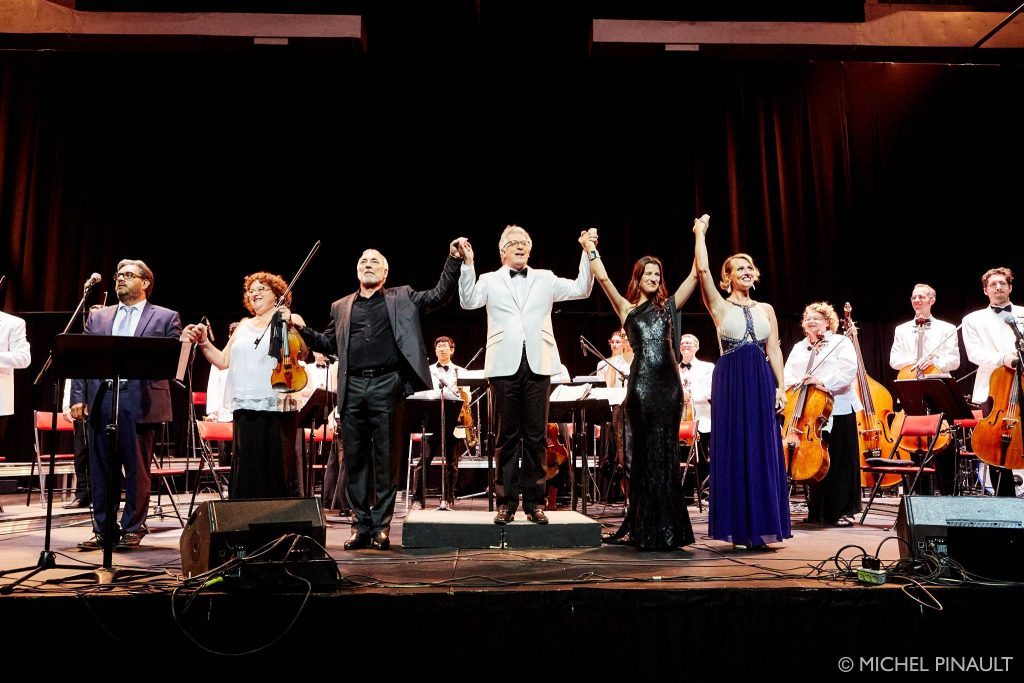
top-left (0, 49), bottom-right (1024, 458)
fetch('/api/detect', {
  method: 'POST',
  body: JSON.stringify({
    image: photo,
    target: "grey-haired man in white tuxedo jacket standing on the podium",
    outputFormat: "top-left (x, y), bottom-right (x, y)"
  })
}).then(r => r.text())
top-left (459, 225), bottom-right (597, 524)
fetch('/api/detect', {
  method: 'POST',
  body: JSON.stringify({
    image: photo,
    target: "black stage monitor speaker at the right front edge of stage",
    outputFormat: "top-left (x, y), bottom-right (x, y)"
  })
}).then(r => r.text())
top-left (895, 496), bottom-right (1024, 581)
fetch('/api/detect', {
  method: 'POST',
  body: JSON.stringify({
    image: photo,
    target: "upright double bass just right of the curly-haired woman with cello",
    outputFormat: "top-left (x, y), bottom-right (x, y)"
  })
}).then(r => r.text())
top-left (843, 301), bottom-right (901, 486)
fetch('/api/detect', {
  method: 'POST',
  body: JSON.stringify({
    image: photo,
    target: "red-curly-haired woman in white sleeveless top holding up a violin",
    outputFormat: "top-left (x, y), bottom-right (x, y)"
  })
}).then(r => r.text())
top-left (181, 272), bottom-right (307, 500)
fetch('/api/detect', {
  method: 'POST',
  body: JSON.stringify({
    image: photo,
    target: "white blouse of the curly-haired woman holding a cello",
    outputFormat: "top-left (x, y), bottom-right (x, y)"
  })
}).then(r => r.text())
top-left (782, 332), bottom-right (862, 417)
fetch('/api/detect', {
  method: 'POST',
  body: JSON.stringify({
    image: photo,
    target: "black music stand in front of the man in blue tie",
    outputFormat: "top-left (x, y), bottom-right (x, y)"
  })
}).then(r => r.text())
top-left (46, 334), bottom-right (184, 584)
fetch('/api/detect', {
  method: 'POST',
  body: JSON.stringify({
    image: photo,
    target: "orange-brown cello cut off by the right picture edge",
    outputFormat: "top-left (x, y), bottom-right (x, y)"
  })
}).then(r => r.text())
top-left (971, 366), bottom-right (1024, 470)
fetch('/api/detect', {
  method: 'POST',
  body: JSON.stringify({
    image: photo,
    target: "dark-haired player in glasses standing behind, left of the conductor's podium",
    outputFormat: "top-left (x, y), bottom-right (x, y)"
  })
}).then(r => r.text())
top-left (413, 337), bottom-right (465, 509)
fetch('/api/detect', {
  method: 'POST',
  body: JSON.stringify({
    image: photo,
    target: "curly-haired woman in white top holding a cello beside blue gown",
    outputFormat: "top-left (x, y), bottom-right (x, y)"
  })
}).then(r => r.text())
top-left (783, 302), bottom-right (861, 526)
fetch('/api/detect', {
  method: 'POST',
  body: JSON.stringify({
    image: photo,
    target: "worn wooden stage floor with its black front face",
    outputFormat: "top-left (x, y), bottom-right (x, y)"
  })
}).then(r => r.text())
top-left (0, 497), bottom-right (1024, 680)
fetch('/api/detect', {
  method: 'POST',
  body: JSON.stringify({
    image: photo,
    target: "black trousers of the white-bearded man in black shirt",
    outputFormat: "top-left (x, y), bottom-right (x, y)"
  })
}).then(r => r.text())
top-left (341, 371), bottom-right (404, 533)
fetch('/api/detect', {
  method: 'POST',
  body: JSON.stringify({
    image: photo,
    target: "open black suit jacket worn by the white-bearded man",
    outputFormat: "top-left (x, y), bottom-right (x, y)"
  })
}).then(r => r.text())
top-left (301, 256), bottom-right (462, 407)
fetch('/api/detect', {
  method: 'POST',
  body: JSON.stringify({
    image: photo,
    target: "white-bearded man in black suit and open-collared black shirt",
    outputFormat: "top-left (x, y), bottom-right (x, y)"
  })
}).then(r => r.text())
top-left (296, 238), bottom-right (463, 550)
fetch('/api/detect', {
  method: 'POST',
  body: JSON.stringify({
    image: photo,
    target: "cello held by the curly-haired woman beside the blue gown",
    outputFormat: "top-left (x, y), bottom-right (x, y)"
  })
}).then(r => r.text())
top-left (782, 338), bottom-right (834, 481)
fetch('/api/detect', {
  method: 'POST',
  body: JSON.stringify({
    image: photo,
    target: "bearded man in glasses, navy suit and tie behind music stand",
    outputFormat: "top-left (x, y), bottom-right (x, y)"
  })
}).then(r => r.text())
top-left (71, 259), bottom-right (181, 550)
